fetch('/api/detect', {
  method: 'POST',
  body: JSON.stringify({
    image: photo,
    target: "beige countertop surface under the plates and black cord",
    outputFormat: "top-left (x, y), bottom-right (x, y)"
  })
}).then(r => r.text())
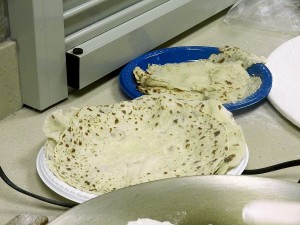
top-left (0, 10), bottom-right (300, 224)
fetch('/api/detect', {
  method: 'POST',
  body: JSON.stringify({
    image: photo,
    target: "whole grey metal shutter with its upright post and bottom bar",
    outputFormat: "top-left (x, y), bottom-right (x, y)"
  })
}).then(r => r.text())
top-left (8, 0), bottom-right (235, 110)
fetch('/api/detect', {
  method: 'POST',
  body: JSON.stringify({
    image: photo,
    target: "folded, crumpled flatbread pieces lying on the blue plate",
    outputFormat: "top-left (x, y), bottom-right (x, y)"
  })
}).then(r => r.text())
top-left (133, 47), bottom-right (266, 103)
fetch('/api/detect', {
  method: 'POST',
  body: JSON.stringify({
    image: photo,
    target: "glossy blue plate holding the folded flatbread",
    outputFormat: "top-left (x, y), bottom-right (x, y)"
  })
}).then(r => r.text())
top-left (119, 46), bottom-right (272, 112)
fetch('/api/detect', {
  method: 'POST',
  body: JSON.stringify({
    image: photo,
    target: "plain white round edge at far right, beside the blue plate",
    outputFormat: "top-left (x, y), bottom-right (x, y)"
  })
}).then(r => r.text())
top-left (266, 36), bottom-right (300, 127)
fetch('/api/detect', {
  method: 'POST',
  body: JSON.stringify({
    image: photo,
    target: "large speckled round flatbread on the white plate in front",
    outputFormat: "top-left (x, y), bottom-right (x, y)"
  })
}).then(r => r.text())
top-left (44, 95), bottom-right (246, 194)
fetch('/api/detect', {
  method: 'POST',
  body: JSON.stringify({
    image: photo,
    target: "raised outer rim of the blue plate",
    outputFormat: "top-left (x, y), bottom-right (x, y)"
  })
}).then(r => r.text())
top-left (119, 46), bottom-right (272, 112)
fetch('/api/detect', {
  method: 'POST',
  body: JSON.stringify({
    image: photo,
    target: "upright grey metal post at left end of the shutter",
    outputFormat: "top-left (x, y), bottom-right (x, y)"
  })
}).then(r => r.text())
top-left (8, 0), bottom-right (68, 110)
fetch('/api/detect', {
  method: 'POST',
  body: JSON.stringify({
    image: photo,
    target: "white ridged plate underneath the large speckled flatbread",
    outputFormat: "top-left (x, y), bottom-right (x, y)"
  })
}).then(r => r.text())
top-left (36, 147), bottom-right (249, 203)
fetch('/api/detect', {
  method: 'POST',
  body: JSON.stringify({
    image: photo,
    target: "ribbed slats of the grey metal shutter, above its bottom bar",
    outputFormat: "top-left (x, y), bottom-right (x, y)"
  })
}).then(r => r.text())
top-left (63, 0), bottom-right (167, 50)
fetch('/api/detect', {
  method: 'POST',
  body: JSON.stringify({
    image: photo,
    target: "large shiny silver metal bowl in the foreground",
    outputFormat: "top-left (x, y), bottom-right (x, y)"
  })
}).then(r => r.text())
top-left (49, 175), bottom-right (300, 225)
